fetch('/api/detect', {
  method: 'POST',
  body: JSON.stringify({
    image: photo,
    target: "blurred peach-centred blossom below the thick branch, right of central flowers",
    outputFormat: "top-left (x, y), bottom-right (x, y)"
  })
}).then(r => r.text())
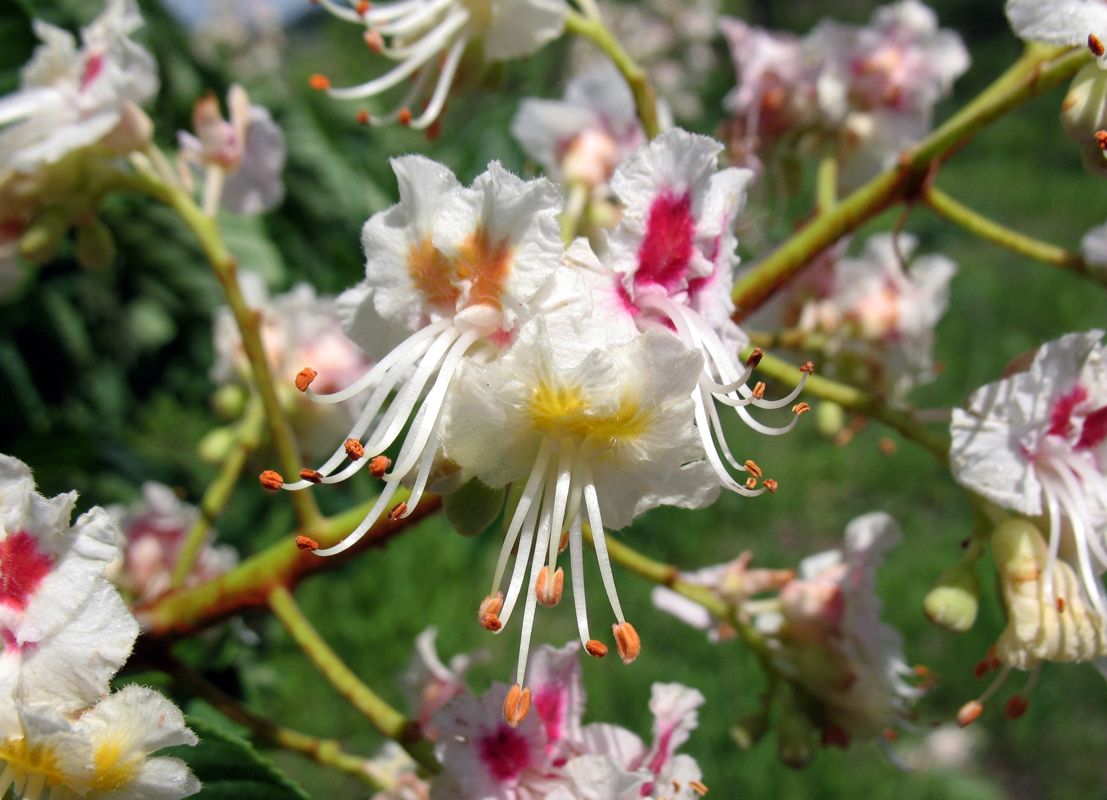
top-left (798, 233), bottom-right (956, 401)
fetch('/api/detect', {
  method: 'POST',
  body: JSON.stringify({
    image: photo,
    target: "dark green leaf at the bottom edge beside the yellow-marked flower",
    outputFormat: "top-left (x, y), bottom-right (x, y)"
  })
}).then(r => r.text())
top-left (164, 717), bottom-right (312, 800)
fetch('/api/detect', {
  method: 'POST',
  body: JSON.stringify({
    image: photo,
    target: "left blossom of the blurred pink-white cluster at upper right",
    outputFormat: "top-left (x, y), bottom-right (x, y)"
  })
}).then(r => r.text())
top-left (720, 17), bottom-right (819, 172)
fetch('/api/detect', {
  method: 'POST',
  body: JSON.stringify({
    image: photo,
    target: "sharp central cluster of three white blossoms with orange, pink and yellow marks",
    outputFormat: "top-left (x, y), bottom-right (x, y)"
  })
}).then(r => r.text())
top-left (262, 129), bottom-right (808, 723)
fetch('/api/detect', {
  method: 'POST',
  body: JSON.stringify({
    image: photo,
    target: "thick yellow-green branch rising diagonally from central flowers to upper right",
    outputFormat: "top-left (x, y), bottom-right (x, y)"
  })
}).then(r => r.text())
top-left (733, 45), bottom-right (1090, 320)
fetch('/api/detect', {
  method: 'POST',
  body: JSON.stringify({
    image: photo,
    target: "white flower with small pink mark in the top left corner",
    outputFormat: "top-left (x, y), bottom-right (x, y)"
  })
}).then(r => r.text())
top-left (0, 0), bottom-right (157, 173)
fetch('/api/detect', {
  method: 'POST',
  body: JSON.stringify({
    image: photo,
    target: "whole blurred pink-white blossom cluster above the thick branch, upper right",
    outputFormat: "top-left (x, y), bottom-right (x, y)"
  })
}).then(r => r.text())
top-left (723, 0), bottom-right (969, 189)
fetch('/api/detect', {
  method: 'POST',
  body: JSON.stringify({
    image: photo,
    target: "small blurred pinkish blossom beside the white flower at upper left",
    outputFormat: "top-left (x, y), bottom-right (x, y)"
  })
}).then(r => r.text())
top-left (177, 83), bottom-right (284, 214)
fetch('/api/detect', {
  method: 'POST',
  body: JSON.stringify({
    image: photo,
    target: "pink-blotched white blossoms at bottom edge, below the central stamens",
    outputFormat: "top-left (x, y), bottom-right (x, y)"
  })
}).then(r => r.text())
top-left (431, 643), bottom-right (706, 800)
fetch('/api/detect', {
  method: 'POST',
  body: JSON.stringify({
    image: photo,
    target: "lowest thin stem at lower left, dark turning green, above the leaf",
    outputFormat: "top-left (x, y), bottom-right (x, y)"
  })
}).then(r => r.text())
top-left (153, 650), bottom-right (395, 791)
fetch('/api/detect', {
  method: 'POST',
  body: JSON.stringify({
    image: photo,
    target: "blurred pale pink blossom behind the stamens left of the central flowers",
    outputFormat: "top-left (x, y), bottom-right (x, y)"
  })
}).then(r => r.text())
top-left (211, 270), bottom-right (372, 454)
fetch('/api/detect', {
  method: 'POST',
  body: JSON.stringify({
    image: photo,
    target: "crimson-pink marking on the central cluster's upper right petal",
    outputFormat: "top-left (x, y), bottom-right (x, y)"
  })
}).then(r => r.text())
top-left (634, 189), bottom-right (695, 294)
